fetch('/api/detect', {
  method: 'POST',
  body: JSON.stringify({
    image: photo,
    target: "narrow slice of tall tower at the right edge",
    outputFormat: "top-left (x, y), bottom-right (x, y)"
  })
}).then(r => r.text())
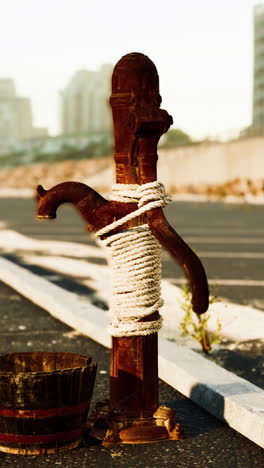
top-left (253, 4), bottom-right (264, 131)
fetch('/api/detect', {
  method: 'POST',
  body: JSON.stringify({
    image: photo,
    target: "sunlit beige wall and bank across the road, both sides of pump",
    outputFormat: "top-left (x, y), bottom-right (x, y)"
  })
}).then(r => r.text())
top-left (0, 138), bottom-right (264, 194)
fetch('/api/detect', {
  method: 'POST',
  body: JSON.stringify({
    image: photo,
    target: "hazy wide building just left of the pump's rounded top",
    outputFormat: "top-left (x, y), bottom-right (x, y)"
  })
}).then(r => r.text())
top-left (61, 65), bottom-right (113, 135)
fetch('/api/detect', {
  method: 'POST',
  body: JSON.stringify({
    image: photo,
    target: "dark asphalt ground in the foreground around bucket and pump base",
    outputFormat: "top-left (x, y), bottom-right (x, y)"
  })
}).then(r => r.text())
top-left (0, 283), bottom-right (263, 468)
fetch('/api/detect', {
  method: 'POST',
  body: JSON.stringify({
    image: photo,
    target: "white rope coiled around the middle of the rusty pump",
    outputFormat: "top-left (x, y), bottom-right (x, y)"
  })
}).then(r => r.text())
top-left (96, 182), bottom-right (171, 336)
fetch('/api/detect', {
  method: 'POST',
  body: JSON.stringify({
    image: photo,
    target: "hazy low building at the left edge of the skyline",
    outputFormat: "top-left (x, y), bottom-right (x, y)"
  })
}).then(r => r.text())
top-left (0, 78), bottom-right (48, 154)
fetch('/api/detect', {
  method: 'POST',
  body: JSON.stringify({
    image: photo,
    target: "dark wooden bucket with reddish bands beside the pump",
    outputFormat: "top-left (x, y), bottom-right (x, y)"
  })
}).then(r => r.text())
top-left (0, 352), bottom-right (96, 455)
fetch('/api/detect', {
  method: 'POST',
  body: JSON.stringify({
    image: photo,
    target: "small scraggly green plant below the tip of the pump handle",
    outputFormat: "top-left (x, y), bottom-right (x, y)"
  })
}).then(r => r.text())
top-left (179, 285), bottom-right (222, 354)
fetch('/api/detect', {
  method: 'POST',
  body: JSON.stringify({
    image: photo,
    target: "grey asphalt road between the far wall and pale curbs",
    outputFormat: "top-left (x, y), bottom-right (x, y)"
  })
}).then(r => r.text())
top-left (0, 198), bottom-right (264, 310)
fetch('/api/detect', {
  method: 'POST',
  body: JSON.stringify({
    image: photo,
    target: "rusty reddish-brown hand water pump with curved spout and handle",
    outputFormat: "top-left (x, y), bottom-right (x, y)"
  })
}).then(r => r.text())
top-left (37, 53), bottom-right (208, 445)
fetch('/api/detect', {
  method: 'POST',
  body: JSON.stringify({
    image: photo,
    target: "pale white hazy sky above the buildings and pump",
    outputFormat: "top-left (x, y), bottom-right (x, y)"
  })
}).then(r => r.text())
top-left (0, 0), bottom-right (263, 138)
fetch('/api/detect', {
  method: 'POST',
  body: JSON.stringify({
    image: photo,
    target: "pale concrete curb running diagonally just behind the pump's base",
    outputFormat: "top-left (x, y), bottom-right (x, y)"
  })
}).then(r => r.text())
top-left (0, 259), bottom-right (264, 447)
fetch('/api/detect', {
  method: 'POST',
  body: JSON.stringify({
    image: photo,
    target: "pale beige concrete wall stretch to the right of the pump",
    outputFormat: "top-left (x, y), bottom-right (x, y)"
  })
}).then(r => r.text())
top-left (158, 137), bottom-right (264, 186)
